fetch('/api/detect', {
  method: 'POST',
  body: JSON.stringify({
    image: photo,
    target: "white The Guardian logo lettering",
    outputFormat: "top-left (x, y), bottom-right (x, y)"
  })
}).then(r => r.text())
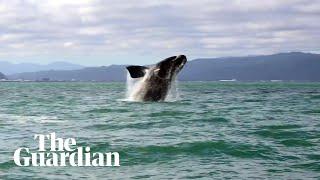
top-left (13, 133), bottom-right (120, 166)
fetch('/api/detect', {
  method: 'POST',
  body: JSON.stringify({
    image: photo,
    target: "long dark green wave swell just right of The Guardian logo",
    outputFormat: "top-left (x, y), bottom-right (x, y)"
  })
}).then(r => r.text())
top-left (120, 140), bottom-right (277, 164)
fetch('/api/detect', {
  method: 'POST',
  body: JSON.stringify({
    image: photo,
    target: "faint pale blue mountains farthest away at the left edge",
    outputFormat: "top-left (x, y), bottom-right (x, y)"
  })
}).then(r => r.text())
top-left (0, 61), bottom-right (84, 74)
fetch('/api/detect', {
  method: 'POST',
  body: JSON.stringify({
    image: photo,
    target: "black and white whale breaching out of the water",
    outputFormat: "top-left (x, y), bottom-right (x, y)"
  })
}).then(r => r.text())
top-left (127, 55), bottom-right (187, 101)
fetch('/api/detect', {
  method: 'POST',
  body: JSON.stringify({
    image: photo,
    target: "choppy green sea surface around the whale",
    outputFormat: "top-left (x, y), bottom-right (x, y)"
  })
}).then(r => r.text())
top-left (0, 82), bottom-right (320, 179)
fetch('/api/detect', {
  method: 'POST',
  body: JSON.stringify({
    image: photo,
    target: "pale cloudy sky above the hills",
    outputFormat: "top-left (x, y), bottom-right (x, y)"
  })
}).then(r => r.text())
top-left (0, 0), bottom-right (320, 65)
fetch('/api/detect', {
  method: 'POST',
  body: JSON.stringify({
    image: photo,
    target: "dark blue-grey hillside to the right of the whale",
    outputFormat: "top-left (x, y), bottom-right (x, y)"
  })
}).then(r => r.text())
top-left (180, 52), bottom-right (320, 81)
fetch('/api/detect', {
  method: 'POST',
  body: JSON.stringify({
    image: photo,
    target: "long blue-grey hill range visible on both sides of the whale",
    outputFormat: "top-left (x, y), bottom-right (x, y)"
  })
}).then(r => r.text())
top-left (9, 52), bottom-right (320, 81)
